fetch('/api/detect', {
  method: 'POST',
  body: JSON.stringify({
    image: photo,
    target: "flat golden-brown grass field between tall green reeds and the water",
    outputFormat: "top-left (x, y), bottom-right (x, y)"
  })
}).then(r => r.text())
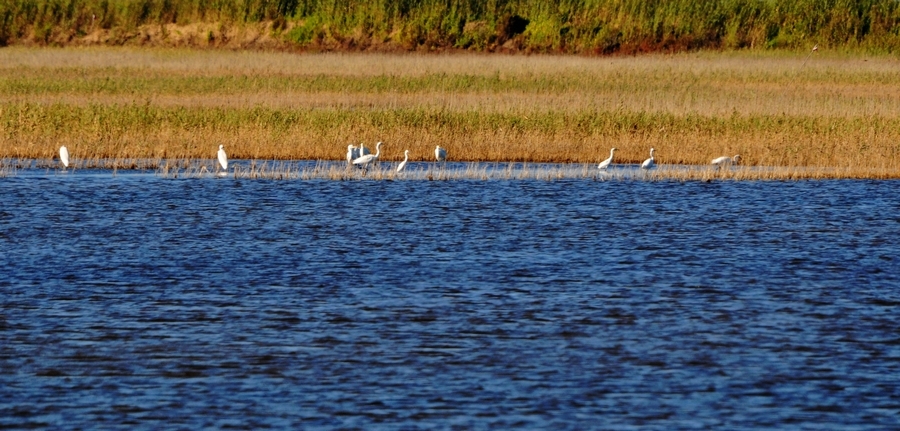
top-left (0, 47), bottom-right (900, 179)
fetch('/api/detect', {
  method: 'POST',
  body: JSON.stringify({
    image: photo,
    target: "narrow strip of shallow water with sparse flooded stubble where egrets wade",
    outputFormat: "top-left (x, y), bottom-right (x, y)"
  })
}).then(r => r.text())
top-left (7, 154), bottom-right (897, 182)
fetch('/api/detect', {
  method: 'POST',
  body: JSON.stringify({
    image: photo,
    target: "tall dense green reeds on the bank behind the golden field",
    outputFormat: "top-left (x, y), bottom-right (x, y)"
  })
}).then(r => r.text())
top-left (0, 0), bottom-right (900, 54)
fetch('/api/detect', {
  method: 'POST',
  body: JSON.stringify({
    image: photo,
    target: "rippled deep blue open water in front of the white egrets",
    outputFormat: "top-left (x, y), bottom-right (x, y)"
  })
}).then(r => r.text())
top-left (0, 170), bottom-right (900, 430)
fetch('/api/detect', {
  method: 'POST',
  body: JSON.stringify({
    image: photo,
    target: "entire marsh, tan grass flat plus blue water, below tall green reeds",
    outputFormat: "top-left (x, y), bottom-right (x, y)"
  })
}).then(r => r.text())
top-left (0, 48), bottom-right (900, 430)
